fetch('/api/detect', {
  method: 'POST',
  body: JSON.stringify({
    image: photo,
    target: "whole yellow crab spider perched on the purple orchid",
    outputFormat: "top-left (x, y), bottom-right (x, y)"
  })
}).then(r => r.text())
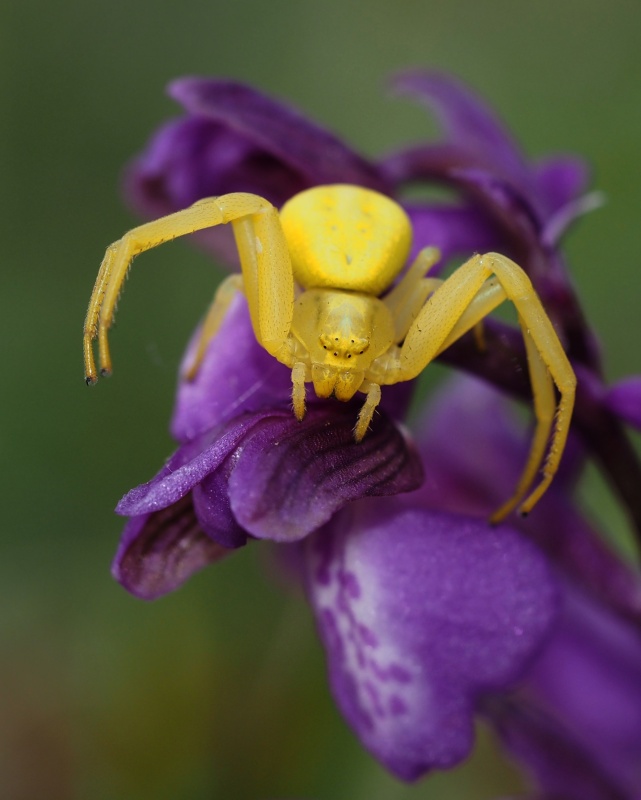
top-left (84, 185), bottom-right (576, 522)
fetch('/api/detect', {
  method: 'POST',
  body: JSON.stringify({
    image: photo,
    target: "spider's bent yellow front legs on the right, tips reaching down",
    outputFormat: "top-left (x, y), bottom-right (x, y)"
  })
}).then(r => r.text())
top-left (399, 253), bottom-right (576, 522)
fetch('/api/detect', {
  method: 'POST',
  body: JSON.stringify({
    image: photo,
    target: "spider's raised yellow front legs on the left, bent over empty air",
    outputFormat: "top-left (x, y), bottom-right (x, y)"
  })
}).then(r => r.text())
top-left (83, 192), bottom-right (294, 383)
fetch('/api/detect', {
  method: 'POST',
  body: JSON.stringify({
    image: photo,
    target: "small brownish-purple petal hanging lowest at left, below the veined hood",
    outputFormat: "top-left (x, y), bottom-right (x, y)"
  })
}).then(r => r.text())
top-left (112, 496), bottom-right (230, 600)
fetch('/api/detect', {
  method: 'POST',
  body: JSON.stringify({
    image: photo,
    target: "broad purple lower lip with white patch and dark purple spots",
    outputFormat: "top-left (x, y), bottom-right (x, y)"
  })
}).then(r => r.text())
top-left (307, 499), bottom-right (556, 780)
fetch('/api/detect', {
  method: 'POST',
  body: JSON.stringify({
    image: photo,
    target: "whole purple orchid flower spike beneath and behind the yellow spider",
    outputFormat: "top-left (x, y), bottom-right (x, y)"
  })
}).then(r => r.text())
top-left (105, 74), bottom-right (641, 788)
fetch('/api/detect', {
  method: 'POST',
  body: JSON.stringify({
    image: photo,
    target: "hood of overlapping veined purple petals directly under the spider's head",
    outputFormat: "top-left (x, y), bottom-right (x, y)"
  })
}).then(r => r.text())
top-left (116, 400), bottom-right (423, 547)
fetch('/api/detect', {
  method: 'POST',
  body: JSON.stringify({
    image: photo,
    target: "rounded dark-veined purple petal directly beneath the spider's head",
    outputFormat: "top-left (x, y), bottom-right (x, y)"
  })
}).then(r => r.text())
top-left (229, 400), bottom-right (423, 542)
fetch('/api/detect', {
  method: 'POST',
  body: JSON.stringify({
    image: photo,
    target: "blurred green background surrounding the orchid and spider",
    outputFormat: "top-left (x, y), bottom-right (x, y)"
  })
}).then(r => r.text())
top-left (0, 0), bottom-right (641, 800)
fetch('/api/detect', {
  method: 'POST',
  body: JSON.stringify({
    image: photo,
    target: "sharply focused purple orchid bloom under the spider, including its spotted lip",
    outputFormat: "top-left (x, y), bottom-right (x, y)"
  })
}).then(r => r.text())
top-left (114, 290), bottom-right (556, 780)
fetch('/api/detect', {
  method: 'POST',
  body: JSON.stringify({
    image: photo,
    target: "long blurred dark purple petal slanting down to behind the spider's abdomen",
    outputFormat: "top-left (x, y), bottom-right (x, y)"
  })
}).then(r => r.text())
top-left (169, 77), bottom-right (387, 191)
